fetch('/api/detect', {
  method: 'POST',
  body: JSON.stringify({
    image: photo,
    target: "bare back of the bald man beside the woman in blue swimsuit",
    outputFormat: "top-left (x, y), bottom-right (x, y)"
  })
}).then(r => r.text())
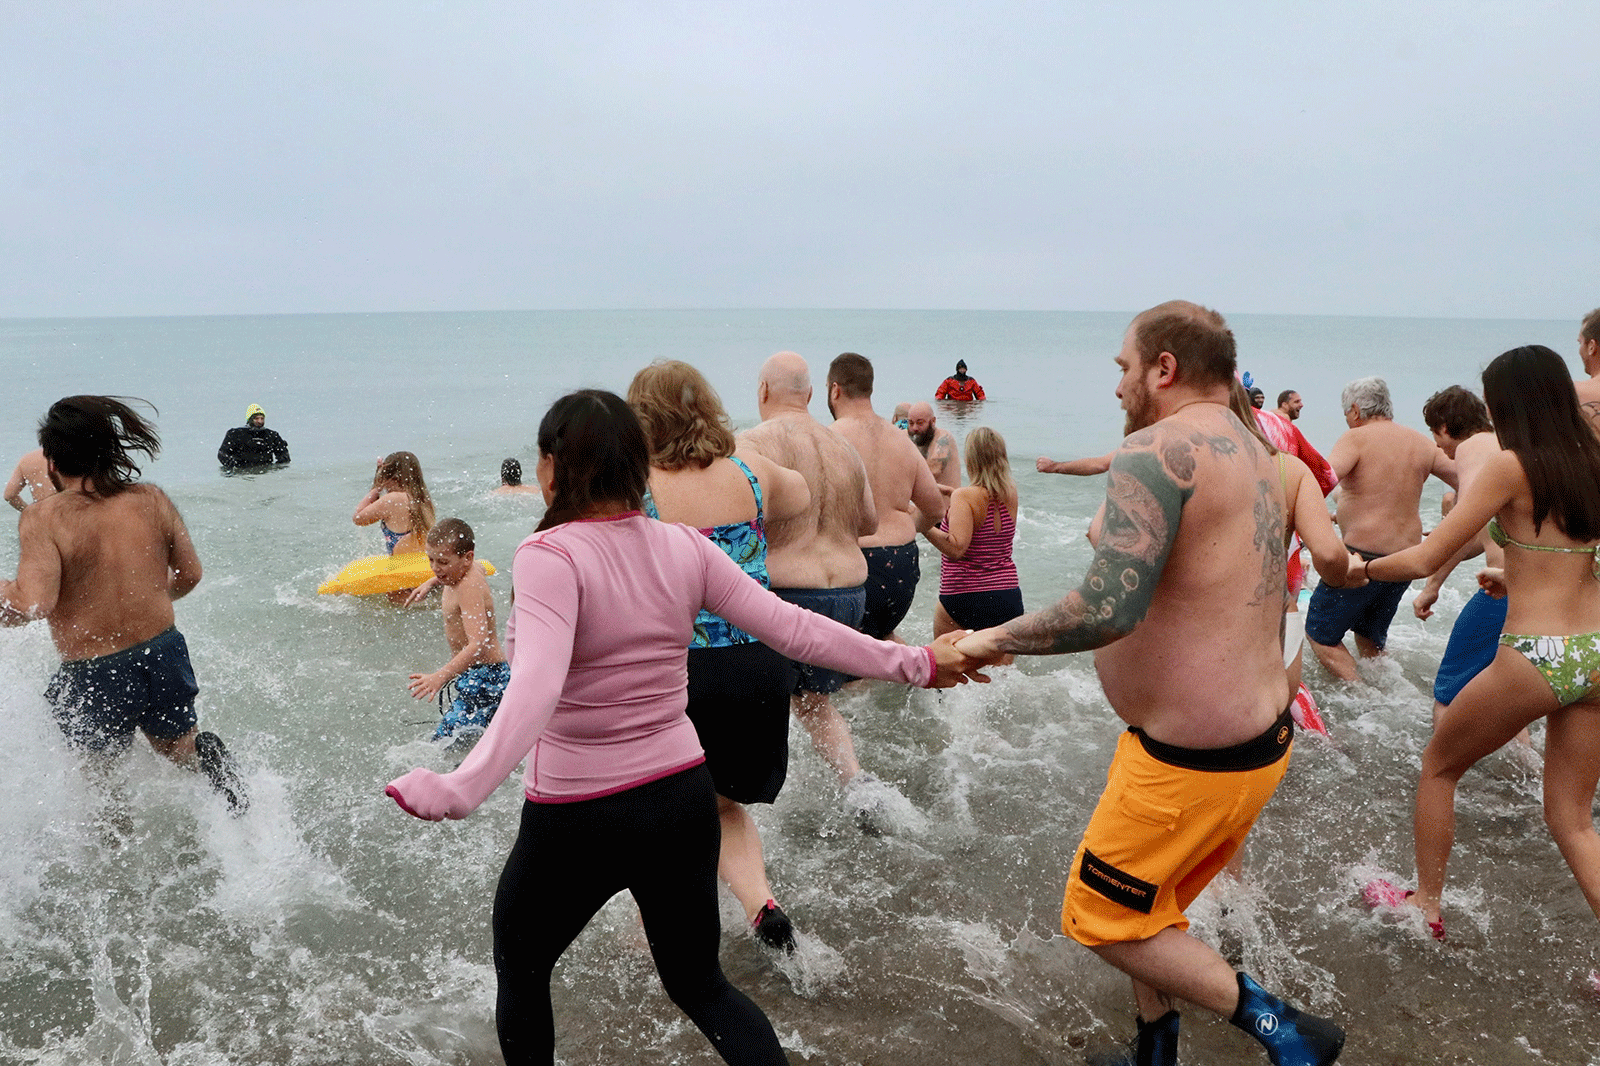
top-left (739, 410), bottom-right (876, 589)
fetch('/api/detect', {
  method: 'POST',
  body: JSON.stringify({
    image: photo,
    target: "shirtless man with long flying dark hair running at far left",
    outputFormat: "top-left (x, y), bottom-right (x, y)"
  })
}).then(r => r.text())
top-left (0, 395), bottom-right (250, 813)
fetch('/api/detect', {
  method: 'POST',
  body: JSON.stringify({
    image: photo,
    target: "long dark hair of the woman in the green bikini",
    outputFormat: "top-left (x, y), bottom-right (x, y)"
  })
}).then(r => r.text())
top-left (1483, 344), bottom-right (1600, 541)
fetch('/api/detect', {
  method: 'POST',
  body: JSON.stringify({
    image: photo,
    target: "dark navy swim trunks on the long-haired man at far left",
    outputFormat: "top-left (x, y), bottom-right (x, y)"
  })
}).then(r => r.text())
top-left (45, 629), bottom-right (200, 755)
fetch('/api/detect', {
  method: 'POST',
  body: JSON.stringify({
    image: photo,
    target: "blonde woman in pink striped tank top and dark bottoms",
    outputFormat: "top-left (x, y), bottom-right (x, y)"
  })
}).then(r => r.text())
top-left (925, 426), bottom-right (1022, 635)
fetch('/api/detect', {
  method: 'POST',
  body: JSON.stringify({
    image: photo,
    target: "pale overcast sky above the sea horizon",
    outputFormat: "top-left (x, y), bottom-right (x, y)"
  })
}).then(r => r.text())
top-left (0, 0), bottom-right (1600, 319)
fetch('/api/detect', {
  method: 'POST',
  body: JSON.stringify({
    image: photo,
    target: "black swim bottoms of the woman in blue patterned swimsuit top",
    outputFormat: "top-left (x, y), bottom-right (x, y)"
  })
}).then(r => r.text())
top-left (688, 643), bottom-right (795, 804)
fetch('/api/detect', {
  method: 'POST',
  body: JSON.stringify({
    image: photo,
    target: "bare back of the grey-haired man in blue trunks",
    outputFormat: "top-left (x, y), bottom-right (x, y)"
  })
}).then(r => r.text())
top-left (1328, 418), bottom-right (1456, 555)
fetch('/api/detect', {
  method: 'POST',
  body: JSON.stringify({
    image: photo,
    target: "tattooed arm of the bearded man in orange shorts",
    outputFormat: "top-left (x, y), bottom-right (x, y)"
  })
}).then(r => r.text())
top-left (962, 429), bottom-right (1195, 656)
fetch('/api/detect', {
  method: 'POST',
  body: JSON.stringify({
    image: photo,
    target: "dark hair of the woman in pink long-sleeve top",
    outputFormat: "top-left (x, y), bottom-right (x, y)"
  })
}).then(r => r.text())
top-left (538, 389), bottom-right (650, 530)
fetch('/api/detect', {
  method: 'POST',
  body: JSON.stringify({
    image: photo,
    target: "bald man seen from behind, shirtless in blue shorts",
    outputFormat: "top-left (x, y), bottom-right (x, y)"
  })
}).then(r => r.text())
top-left (739, 352), bottom-right (878, 813)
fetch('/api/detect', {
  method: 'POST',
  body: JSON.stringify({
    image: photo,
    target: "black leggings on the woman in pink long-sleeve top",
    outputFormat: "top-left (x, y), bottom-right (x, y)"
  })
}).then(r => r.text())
top-left (494, 763), bottom-right (789, 1066)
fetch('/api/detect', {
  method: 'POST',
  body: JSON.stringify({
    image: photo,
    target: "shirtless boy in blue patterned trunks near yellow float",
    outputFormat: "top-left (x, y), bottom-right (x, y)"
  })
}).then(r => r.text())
top-left (406, 519), bottom-right (510, 739)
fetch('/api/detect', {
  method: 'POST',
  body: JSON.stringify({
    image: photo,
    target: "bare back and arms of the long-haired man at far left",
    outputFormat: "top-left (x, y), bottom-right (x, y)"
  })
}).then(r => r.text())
top-left (0, 485), bottom-right (200, 661)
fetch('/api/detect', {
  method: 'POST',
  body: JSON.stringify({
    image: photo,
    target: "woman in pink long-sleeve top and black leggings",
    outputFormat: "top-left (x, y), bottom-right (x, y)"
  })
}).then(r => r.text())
top-left (387, 391), bottom-right (966, 1063)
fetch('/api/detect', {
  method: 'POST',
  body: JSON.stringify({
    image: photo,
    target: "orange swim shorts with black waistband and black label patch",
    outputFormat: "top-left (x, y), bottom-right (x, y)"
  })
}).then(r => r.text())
top-left (1061, 711), bottom-right (1294, 948)
